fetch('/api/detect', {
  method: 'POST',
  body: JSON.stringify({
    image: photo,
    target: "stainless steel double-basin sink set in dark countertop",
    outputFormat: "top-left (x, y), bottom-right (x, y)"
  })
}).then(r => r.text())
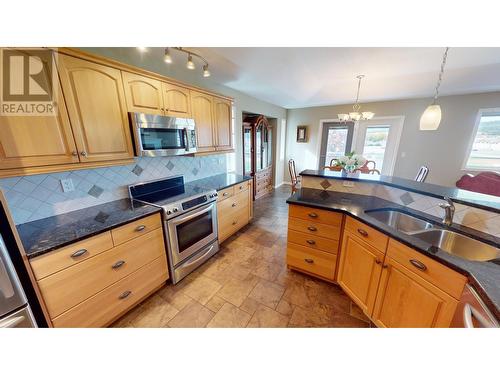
top-left (365, 208), bottom-right (500, 262)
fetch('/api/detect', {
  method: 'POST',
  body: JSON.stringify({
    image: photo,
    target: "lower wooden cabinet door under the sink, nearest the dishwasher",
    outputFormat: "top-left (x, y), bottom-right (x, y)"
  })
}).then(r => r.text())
top-left (372, 257), bottom-right (458, 328)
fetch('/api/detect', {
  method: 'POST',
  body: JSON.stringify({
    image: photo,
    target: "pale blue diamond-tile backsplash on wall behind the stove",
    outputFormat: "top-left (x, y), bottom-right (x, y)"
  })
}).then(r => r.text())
top-left (0, 154), bottom-right (228, 224)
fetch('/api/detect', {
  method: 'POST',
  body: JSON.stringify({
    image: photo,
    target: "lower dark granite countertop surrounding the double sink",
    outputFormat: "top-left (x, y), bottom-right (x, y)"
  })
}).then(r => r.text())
top-left (287, 188), bottom-right (500, 320)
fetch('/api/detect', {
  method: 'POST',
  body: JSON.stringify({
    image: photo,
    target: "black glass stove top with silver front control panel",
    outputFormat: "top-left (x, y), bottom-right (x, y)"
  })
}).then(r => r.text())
top-left (129, 176), bottom-right (217, 219)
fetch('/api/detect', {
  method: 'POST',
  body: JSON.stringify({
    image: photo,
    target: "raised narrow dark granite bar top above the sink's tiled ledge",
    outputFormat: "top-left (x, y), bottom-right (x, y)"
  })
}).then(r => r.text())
top-left (300, 169), bottom-right (500, 213)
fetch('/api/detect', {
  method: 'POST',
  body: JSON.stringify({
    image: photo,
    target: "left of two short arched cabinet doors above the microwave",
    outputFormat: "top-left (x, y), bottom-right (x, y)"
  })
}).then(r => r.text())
top-left (122, 72), bottom-right (164, 115)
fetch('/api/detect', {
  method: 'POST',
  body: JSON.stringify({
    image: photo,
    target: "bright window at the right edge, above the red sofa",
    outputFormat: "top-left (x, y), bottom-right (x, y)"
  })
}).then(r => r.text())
top-left (465, 109), bottom-right (500, 170)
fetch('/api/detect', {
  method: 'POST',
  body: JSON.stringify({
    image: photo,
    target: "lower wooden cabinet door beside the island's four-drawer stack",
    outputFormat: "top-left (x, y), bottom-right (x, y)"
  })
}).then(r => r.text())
top-left (337, 231), bottom-right (384, 316)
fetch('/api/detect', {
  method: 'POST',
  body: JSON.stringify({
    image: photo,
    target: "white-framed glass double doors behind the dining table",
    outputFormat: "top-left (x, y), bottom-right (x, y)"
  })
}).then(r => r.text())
top-left (319, 116), bottom-right (404, 176)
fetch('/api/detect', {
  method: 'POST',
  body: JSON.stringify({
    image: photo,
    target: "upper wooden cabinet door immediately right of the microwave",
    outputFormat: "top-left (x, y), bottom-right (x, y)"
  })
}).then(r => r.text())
top-left (191, 91), bottom-right (215, 152)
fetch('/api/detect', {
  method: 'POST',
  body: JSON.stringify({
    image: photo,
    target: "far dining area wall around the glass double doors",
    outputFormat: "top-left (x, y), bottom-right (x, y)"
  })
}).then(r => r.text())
top-left (285, 92), bottom-right (500, 186)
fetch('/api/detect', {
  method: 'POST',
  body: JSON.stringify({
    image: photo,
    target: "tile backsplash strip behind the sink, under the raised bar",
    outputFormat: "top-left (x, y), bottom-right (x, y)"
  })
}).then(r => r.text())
top-left (301, 176), bottom-right (500, 237)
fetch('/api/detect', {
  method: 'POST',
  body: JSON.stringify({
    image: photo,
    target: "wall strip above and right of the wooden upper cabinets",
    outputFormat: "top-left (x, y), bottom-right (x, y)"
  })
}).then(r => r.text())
top-left (79, 47), bottom-right (286, 173)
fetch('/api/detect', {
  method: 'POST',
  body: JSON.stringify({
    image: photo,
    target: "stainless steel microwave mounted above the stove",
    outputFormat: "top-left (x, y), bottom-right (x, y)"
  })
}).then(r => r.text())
top-left (129, 112), bottom-right (196, 156)
